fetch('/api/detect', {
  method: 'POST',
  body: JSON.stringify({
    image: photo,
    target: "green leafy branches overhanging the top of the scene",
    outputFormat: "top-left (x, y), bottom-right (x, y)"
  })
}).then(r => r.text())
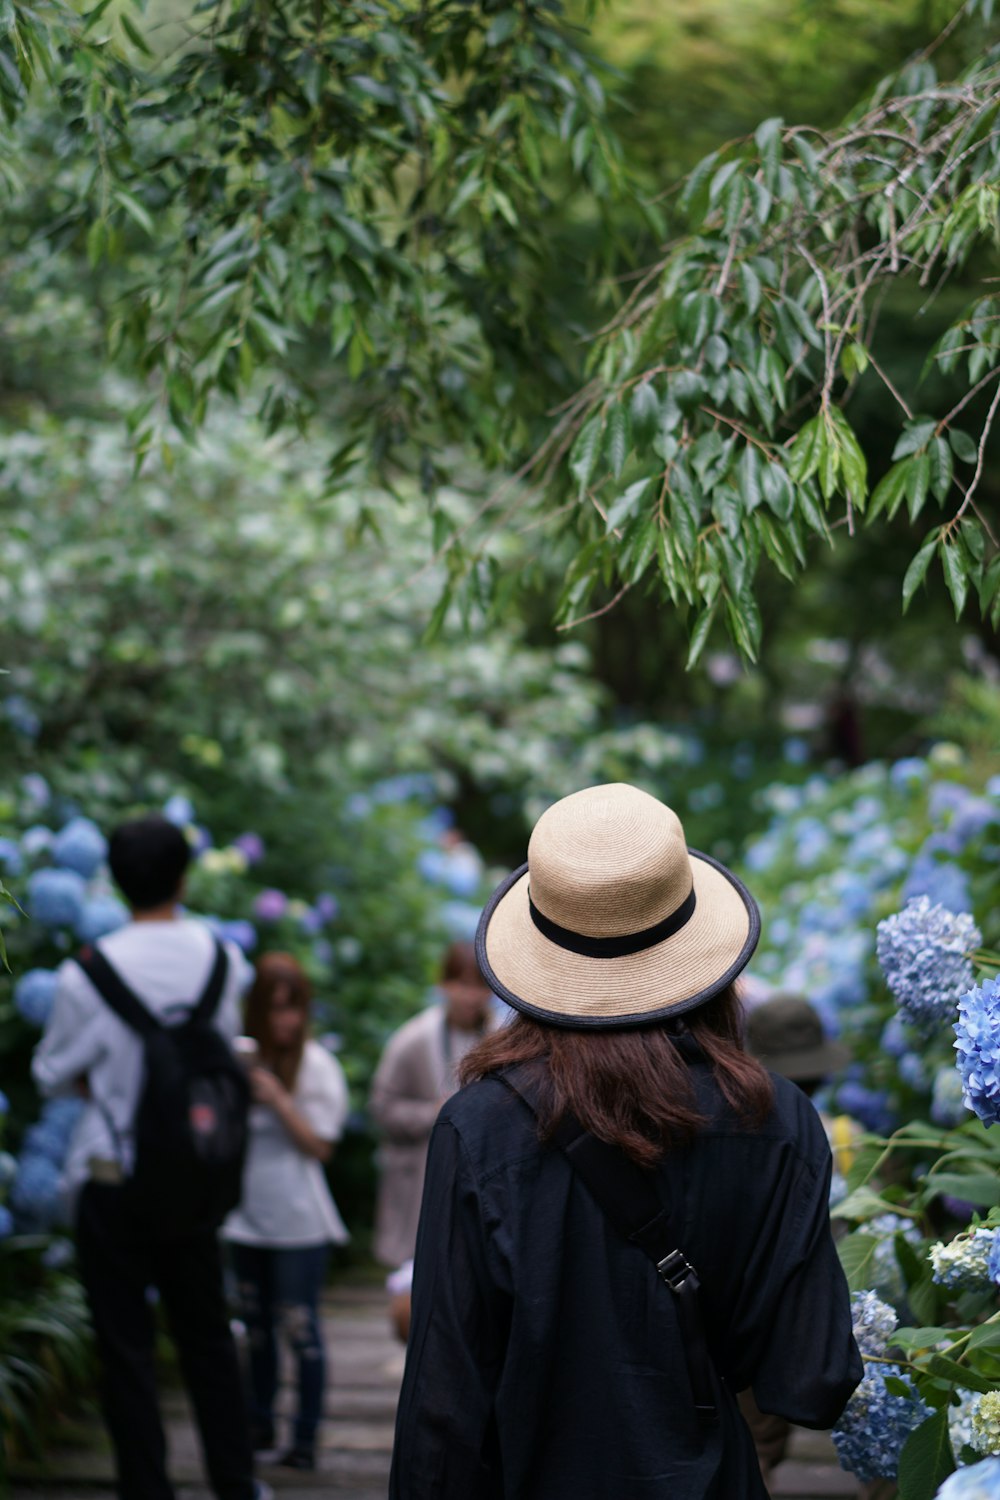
top-left (0, 0), bottom-right (1000, 662)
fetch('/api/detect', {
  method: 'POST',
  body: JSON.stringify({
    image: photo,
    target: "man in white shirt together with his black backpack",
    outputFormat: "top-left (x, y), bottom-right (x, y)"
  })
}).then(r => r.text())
top-left (33, 816), bottom-right (270, 1500)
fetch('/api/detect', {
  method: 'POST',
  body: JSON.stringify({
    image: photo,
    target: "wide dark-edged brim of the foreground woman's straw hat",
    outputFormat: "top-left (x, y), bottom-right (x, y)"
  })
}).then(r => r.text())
top-left (475, 849), bottom-right (760, 1029)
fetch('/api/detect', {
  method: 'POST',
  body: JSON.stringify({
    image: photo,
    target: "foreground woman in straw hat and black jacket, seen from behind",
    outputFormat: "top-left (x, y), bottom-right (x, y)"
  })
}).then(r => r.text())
top-left (390, 785), bottom-right (862, 1500)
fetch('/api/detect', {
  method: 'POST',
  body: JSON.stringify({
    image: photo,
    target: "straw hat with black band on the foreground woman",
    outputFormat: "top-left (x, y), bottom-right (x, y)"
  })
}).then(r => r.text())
top-left (475, 783), bottom-right (760, 1028)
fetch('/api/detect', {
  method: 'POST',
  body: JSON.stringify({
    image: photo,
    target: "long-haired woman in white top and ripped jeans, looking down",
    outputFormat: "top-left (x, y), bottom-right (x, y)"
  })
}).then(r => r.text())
top-left (222, 953), bottom-right (348, 1469)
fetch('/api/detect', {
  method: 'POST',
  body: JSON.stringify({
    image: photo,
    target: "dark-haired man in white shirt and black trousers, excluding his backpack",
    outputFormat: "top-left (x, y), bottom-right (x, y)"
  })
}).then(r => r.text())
top-left (31, 816), bottom-right (270, 1500)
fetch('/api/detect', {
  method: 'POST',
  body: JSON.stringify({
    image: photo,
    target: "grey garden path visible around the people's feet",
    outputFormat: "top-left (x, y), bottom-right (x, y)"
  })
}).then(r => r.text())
top-left (9, 1283), bottom-right (856, 1500)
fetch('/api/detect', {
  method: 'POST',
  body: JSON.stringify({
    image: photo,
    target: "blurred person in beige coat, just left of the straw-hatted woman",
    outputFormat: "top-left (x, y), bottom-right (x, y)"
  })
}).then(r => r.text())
top-left (370, 942), bottom-right (495, 1266)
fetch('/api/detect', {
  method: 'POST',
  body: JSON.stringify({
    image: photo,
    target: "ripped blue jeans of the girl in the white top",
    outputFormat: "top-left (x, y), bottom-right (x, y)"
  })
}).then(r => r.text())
top-left (229, 1244), bottom-right (330, 1449)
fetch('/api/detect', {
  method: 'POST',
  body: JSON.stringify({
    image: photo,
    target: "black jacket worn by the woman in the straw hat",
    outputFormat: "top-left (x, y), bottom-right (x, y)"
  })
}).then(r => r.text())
top-left (390, 1064), bottom-right (862, 1500)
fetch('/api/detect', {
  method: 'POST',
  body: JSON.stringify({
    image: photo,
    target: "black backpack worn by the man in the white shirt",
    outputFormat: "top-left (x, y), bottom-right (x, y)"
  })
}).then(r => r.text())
top-left (76, 939), bottom-right (250, 1239)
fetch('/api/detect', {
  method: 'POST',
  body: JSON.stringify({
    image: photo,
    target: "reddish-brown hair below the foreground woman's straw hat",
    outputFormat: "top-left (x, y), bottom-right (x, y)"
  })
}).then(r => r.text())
top-left (460, 986), bottom-right (774, 1167)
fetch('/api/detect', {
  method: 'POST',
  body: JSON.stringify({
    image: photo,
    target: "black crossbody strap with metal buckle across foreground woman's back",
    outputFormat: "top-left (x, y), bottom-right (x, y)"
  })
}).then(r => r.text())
top-left (495, 1067), bottom-right (718, 1427)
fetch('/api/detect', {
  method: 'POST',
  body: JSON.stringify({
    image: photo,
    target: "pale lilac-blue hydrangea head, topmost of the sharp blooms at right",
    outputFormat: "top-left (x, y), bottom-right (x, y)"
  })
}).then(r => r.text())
top-left (876, 896), bottom-right (982, 1034)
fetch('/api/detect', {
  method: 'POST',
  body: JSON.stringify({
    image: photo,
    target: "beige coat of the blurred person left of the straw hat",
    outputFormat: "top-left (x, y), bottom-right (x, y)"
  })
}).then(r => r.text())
top-left (370, 1005), bottom-right (491, 1266)
